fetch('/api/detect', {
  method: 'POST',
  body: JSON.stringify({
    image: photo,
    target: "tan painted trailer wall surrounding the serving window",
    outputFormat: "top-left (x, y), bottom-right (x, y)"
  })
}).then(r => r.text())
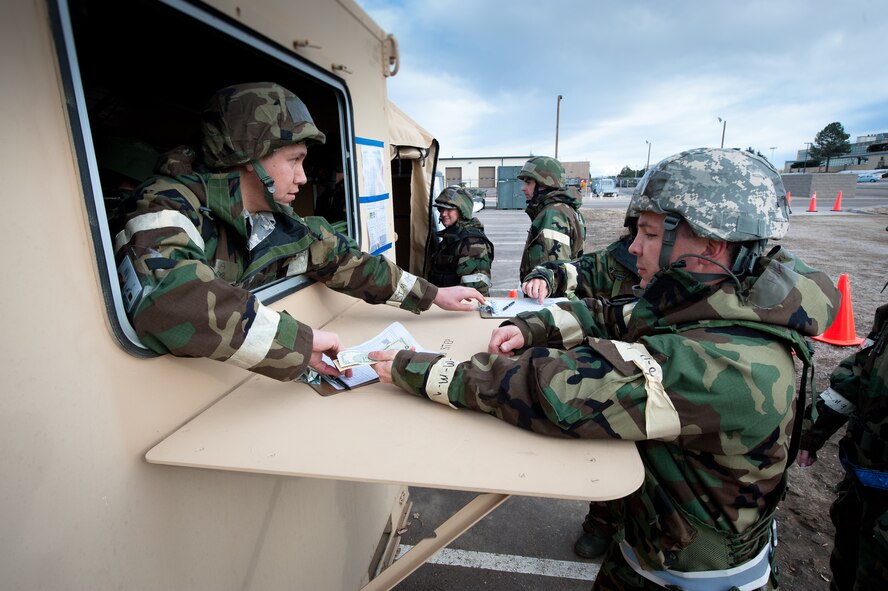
top-left (0, 0), bottom-right (400, 589)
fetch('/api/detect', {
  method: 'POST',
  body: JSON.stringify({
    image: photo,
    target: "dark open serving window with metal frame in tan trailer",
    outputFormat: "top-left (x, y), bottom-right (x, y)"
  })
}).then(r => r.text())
top-left (49, 0), bottom-right (360, 355)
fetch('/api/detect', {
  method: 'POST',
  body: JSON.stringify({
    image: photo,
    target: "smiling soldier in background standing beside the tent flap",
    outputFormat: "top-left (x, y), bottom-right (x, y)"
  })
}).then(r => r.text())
top-left (429, 186), bottom-right (493, 295)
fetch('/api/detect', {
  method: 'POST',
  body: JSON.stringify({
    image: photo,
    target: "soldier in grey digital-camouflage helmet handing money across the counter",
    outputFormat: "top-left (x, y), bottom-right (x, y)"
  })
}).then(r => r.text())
top-left (371, 148), bottom-right (839, 591)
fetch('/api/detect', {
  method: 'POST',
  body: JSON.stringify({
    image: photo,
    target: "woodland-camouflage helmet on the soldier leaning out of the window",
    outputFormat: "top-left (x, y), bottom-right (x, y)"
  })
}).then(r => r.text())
top-left (202, 82), bottom-right (326, 168)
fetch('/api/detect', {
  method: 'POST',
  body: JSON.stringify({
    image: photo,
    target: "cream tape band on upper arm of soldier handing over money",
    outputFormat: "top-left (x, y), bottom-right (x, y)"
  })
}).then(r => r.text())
top-left (611, 341), bottom-right (681, 441)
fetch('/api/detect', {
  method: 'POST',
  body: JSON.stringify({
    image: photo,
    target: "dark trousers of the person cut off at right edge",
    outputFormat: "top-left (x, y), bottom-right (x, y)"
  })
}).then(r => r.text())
top-left (829, 476), bottom-right (888, 591)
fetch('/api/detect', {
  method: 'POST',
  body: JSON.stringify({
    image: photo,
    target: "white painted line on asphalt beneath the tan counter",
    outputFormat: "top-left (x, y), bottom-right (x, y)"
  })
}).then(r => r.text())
top-left (398, 544), bottom-right (601, 581)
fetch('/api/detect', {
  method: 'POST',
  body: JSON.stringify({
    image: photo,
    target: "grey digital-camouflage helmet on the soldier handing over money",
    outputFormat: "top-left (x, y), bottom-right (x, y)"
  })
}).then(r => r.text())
top-left (626, 148), bottom-right (789, 242)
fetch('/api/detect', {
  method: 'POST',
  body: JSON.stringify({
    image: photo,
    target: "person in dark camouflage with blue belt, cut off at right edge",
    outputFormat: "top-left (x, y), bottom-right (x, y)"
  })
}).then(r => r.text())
top-left (798, 305), bottom-right (888, 591)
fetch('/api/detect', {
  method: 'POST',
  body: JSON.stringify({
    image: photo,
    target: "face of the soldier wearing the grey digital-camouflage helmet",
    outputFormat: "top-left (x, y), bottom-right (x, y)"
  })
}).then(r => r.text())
top-left (629, 211), bottom-right (711, 287)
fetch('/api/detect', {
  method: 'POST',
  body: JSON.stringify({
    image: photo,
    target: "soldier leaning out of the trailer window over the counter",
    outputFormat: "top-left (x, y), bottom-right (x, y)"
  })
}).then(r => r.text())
top-left (115, 83), bottom-right (483, 380)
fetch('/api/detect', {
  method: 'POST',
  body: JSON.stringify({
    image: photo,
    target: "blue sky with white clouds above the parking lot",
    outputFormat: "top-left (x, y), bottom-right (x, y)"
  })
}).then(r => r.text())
top-left (357, 0), bottom-right (888, 176)
